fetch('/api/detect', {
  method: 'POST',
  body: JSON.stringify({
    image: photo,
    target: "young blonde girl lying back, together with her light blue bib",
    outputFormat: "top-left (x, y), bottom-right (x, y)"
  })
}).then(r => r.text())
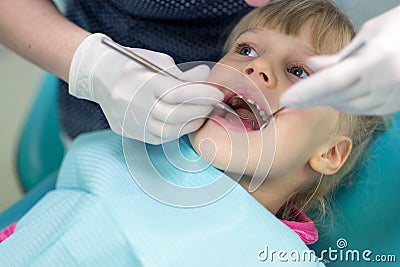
top-left (0, 0), bottom-right (378, 266)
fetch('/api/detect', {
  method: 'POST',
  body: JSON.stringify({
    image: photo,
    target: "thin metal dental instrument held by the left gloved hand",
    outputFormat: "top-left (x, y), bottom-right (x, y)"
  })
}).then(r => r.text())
top-left (101, 37), bottom-right (255, 129)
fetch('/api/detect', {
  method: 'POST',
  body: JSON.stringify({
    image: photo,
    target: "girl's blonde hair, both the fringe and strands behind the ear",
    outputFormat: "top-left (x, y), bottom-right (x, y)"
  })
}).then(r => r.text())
top-left (224, 0), bottom-right (379, 219)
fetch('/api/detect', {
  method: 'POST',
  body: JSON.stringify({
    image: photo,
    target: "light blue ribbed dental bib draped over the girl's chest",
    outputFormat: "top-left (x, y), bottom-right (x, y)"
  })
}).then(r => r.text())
top-left (0, 130), bottom-right (323, 267)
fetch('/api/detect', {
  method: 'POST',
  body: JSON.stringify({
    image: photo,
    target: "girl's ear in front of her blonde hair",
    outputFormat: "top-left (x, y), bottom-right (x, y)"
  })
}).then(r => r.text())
top-left (309, 136), bottom-right (353, 175)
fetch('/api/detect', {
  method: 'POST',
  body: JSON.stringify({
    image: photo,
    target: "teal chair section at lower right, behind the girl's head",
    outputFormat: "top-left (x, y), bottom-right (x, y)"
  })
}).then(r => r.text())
top-left (312, 113), bottom-right (400, 267)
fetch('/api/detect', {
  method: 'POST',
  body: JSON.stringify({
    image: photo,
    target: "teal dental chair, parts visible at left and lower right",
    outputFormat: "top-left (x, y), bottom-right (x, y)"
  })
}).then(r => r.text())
top-left (0, 75), bottom-right (400, 267)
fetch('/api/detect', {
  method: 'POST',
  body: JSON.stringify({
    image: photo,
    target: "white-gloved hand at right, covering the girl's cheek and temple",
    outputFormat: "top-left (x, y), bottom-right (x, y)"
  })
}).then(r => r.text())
top-left (280, 6), bottom-right (400, 115)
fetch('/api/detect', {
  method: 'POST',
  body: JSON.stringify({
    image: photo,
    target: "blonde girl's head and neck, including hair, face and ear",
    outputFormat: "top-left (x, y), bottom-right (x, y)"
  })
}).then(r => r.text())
top-left (190, 0), bottom-right (378, 239)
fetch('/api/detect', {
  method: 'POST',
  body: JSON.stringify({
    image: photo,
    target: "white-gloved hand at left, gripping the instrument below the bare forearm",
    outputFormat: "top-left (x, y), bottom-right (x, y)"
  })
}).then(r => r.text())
top-left (69, 33), bottom-right (224, 144)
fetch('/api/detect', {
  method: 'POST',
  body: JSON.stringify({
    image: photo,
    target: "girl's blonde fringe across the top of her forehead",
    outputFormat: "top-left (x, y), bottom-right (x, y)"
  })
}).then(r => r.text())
top-left (224, 0), bottom-right (355, 54)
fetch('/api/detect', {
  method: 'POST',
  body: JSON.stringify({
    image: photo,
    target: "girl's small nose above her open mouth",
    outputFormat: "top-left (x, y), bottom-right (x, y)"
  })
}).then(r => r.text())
top-left (243, 58), bottom-right (276, 89)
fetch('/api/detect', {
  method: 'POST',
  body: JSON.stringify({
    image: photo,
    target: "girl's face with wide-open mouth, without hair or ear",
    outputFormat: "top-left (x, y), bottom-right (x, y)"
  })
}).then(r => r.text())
top-left (190, 27), bottom-right (339, 211)
